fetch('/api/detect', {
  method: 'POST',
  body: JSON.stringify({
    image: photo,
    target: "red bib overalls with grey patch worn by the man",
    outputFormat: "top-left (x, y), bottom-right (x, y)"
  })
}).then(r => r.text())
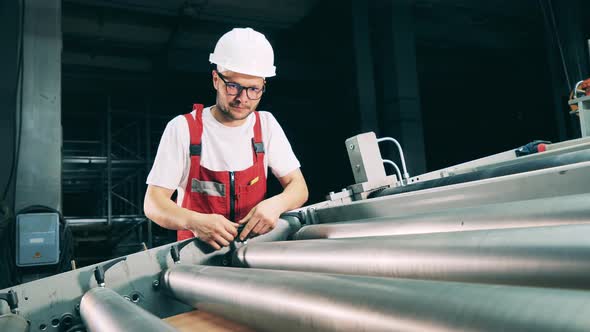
top-left (177, 104), bottom-right (266, 241)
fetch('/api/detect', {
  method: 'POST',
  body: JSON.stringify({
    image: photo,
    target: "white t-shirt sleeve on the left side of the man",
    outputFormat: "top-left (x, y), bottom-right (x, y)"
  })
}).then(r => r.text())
top-left (146, 116), bottom-right (189, 190)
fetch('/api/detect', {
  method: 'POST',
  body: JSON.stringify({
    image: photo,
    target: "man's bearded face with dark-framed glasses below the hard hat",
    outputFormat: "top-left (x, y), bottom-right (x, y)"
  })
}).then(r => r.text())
top-left (213, 70), bottom-right (264, 122)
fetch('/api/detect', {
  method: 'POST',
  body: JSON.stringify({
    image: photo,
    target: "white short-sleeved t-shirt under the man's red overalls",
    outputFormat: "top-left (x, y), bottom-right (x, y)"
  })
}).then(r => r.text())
top-left (146, 107), bottom-right (301, 205)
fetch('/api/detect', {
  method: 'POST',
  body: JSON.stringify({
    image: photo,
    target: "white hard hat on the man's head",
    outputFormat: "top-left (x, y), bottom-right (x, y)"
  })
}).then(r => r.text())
top-left (209, 28), bottom-right (276, 77)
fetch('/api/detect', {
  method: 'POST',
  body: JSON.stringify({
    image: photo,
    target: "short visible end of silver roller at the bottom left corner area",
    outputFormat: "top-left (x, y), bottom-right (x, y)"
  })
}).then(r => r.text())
top-left (80, 287), bottom-right (176, 332)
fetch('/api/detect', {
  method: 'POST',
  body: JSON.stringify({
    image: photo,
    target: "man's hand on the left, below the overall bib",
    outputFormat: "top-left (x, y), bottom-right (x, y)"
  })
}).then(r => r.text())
top-left (191, 214), bottom-right (238, 250)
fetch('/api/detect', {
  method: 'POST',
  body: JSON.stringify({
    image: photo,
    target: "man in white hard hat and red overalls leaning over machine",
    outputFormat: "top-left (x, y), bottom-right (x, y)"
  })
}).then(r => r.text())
top-left (144, 28), bottom-right (308, 249)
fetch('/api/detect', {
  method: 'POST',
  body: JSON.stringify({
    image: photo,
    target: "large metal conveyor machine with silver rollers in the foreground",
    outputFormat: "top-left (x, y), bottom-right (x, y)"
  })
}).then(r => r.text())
top-left (0, 133), bottom-right (590, 332)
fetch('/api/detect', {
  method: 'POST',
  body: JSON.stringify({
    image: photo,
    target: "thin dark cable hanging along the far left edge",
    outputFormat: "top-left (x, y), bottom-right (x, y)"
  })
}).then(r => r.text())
top-left (2, 0), bottom-right (25, 201)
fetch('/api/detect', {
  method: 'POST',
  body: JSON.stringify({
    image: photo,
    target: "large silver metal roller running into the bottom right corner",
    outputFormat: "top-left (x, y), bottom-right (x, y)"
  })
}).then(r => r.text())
top-left (162, 265), bottom-right (590, 332)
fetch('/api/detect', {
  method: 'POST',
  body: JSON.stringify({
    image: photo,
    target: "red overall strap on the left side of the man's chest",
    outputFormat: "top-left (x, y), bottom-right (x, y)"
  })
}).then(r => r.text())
top-left (182, 104), bottom-right (203, 207)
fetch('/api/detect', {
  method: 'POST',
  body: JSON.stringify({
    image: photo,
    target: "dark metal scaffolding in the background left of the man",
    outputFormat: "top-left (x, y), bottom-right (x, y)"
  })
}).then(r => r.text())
top-left (62, 96), bottom-right (169, 264)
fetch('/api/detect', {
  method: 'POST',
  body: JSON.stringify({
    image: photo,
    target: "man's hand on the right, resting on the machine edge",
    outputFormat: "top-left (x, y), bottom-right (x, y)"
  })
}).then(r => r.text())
top-left (238, 197), bottom-right (283, 241)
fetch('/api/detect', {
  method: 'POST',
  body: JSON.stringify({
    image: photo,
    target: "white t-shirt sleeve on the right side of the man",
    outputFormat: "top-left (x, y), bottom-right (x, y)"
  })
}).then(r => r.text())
top-left (266, 113), bottom-right (301, 178)
